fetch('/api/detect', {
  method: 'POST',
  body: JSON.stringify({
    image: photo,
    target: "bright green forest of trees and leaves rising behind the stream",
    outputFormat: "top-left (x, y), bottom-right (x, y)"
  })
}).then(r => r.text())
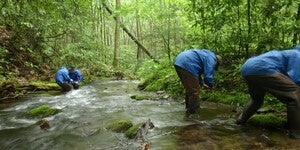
top-left (0, 0), bottom-right (300, 84)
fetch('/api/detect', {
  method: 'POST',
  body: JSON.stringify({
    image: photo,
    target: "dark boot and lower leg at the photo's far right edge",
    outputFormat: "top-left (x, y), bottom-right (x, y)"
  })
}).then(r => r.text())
top-left (287, 105), bottom-right (300, 139)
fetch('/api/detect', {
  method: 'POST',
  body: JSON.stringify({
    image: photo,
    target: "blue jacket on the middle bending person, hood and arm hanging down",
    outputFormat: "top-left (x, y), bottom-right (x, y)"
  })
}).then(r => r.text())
top-left (174, 49), bottom-right (217, 87)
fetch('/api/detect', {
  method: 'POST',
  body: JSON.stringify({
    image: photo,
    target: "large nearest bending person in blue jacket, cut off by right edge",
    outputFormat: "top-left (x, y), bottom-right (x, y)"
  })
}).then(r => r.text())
top-left (236, 46), bottom-right (300, 138)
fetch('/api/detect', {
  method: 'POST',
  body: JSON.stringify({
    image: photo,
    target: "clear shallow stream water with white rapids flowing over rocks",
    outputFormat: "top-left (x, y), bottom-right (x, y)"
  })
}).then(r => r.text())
top-left (0, 80), bottom-right (300, 150)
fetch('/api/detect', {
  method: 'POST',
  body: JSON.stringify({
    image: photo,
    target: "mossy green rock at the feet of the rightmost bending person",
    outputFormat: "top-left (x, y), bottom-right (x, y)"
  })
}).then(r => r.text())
top-left (249, 114), bottom-right (287, 128)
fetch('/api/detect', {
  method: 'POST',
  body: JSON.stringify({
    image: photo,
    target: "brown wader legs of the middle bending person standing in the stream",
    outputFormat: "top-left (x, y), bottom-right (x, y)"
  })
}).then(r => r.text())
top-left (174, 66), bottom-right (200, 114)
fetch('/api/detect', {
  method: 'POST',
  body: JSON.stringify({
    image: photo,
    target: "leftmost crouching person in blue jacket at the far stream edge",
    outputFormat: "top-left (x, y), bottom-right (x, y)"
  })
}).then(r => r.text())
top-left (55, 67), bottom-right (73, 91)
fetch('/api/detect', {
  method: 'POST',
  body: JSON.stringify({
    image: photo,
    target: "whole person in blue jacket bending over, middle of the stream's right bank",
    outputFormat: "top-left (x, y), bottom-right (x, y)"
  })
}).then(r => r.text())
top-left (174, 49), bottom-right (221, 115)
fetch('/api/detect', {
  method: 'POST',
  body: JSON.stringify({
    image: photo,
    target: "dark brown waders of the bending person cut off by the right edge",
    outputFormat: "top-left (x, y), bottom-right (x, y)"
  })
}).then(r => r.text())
top-left (239, 73), bottom-right (300, 137)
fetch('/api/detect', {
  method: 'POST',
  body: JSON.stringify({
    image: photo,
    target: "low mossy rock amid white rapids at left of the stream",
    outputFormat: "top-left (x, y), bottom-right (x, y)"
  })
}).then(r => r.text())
top-left (28, 105), bottom-right (62, 117)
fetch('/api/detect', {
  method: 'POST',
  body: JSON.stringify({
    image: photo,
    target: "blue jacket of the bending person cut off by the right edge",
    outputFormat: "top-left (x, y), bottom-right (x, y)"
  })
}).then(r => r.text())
top-left (242, 46), bottom-right (300, 85)
